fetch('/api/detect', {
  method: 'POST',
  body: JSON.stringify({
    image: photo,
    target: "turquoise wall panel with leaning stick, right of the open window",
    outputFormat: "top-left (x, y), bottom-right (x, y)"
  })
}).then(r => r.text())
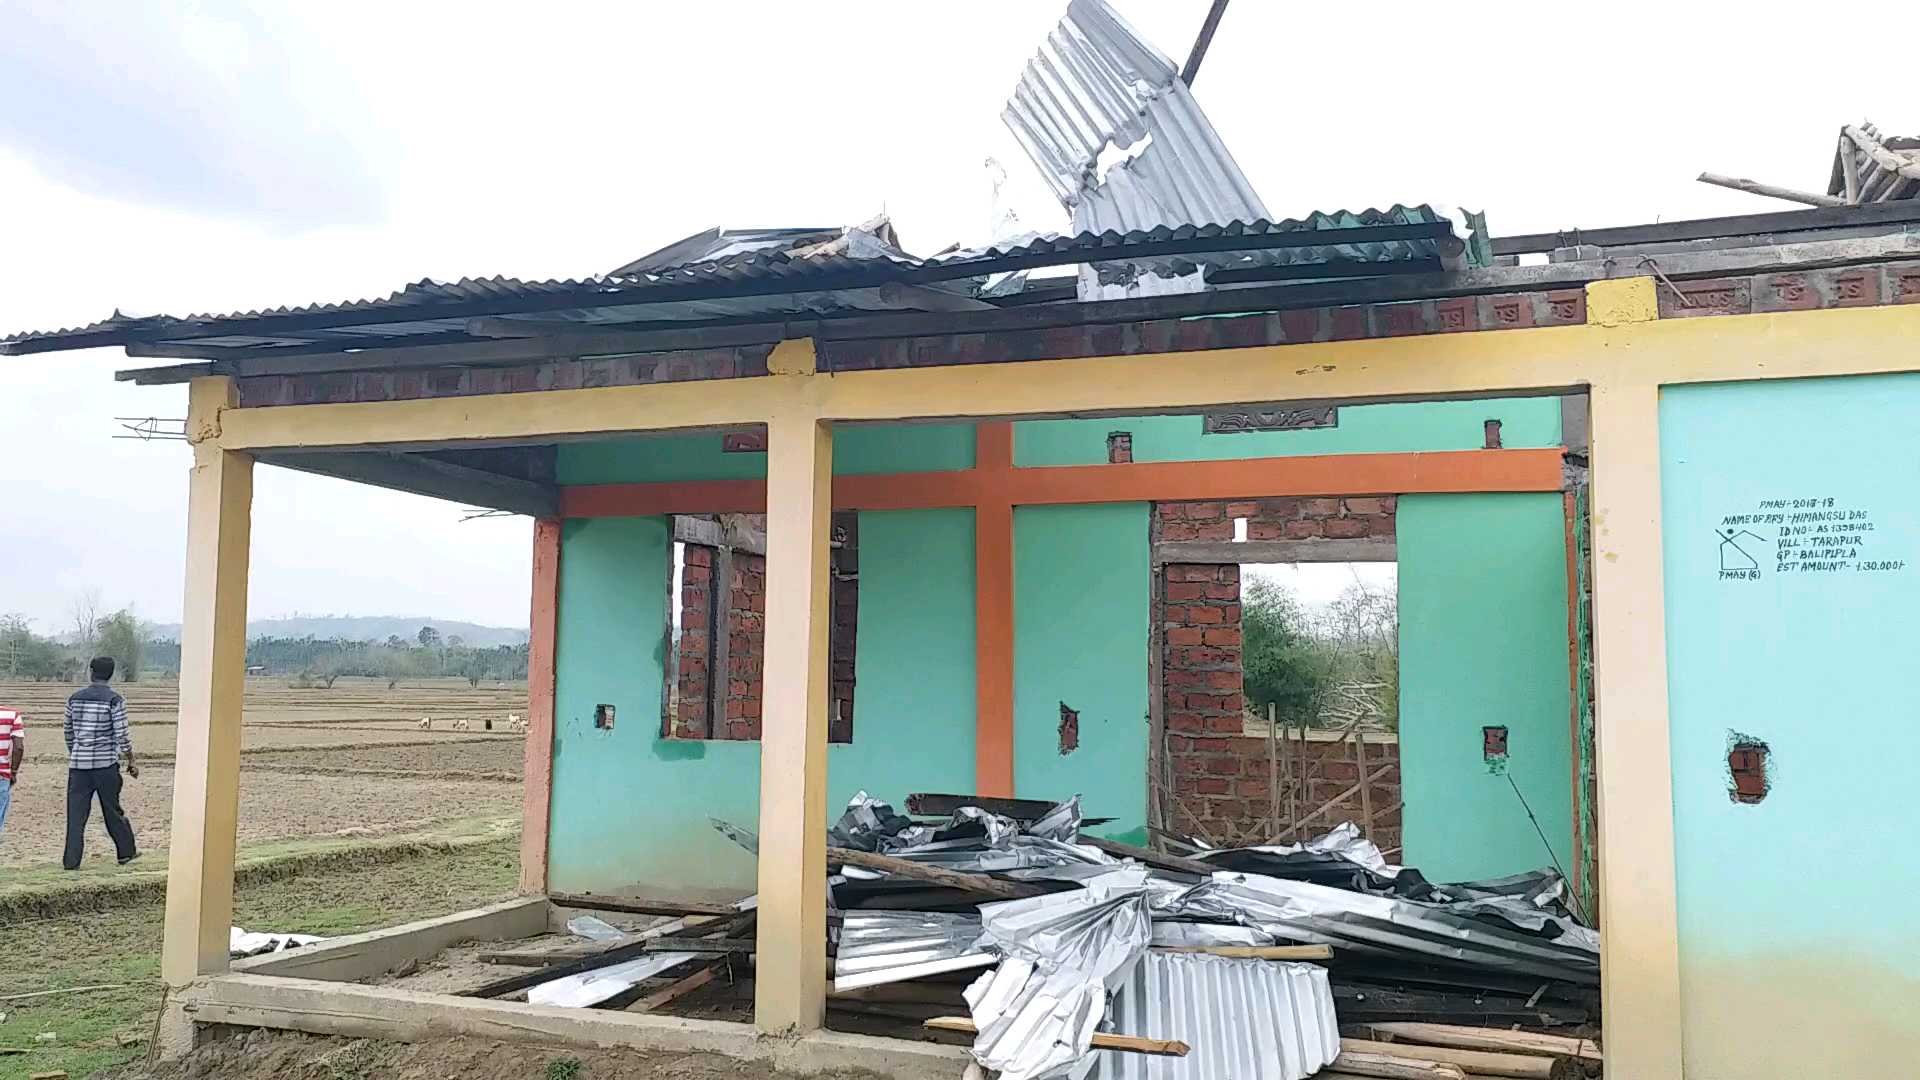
top-left (1398, 492), bottom-right (1572, 880)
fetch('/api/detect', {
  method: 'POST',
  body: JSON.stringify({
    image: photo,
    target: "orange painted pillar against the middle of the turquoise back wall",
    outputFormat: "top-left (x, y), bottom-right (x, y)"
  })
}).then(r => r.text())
top-left (973, 423), bottom-right (1014, 798)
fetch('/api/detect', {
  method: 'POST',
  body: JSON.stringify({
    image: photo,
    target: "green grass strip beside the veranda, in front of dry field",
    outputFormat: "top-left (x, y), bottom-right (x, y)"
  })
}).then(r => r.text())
top-left (0, 836), bottom-right (520, 1080)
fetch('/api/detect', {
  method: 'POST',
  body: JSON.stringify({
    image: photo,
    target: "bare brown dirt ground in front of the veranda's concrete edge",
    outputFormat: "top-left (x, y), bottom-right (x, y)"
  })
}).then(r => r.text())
top-left (111, 1032), bottom-right (894, 1080)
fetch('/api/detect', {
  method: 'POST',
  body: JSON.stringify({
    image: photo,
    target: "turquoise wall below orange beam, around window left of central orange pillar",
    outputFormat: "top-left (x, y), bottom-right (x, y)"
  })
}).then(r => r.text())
top-left (547, 509), bottom-right (973, 896)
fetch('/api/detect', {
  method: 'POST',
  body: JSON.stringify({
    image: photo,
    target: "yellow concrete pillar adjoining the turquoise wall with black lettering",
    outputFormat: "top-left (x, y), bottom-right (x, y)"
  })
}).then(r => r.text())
top-left (1588, 279), bottom-right (1682, 1080)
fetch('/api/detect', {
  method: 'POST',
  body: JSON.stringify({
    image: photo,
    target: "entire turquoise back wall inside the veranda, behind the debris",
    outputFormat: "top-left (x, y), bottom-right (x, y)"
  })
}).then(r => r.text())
top-left (551, 398), bottom-right (1571, 892)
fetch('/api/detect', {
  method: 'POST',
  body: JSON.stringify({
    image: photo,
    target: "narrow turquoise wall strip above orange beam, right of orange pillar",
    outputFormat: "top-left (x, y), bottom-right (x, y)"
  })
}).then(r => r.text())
top-left (1014, 398), bottom-right (1561, 465)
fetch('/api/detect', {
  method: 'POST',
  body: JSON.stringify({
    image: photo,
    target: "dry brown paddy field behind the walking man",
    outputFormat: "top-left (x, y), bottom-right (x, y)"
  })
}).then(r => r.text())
top-left (0, 678), bottom-right (526, 876)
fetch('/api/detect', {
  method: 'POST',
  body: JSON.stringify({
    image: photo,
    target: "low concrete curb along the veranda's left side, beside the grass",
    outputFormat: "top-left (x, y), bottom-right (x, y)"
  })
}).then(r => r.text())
top-left (232, 896), bottom-right (547, 982)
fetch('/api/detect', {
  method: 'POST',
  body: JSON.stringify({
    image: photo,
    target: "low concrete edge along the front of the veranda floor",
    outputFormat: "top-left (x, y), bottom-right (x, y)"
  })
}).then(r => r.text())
top-left (175, 974), bottom-right (968, 1080)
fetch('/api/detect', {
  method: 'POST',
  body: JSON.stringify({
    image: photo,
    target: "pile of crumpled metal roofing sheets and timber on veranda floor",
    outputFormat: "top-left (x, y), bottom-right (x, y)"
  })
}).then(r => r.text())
top-left (468, 794), bottom-right (1601, 1080)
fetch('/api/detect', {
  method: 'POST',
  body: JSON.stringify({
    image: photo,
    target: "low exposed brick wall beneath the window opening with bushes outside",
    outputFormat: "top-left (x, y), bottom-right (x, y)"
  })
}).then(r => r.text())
top-left (1167, 728), bottom-right (1402, 851)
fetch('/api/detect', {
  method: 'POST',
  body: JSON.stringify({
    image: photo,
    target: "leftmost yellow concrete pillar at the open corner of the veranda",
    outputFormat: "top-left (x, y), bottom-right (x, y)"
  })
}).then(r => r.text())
top-left (159, 377), bottom-right (253, 986)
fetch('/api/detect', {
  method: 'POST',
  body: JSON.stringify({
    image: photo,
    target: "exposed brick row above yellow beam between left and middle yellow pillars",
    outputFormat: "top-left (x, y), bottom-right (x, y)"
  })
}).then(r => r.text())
top-left (234, 346), bottom-right (772, 407)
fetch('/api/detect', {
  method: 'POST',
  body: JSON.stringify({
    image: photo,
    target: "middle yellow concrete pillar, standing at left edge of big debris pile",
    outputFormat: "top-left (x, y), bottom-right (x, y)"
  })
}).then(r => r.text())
top-left (753, 388), bottom-right (833, 1034)
